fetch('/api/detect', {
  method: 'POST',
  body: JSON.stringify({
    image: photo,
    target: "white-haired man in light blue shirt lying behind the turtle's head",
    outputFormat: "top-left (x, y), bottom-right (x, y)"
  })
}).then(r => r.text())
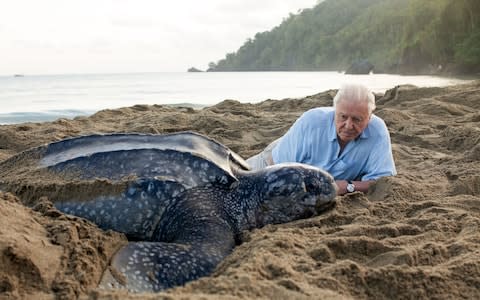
top-left (247, 84), bottom-right (397, 195)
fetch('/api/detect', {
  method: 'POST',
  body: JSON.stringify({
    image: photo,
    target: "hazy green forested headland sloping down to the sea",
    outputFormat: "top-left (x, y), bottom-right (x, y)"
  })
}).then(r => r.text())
top-left (209, 0), bottom-right (480, 73)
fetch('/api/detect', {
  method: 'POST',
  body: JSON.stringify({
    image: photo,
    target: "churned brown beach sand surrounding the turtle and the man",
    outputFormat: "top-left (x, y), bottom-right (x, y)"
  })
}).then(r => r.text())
top-left (0, 82), bottom-right (480, 299)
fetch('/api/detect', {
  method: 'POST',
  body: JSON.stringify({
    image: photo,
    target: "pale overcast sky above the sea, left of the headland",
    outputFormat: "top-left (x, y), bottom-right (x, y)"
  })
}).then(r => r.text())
top-left (0, 0), bottom-right (317, 75)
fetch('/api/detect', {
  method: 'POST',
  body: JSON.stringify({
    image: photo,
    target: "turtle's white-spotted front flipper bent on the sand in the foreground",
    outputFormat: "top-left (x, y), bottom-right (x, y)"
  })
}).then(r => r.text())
top-left (99, 200), bottom-right (235, 292)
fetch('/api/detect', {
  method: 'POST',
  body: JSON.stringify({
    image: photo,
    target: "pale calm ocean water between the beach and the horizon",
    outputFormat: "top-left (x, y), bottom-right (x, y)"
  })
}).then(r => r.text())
top-left (0, 72), bottom-right (468, 124)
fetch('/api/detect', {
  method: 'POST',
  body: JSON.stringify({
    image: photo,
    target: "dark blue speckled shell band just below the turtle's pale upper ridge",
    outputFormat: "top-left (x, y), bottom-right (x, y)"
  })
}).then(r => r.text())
top-left (47, 149), bottom-right (237, 187)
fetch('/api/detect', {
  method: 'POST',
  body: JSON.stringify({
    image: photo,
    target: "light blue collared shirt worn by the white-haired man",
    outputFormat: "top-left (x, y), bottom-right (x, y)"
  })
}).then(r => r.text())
top-left (272, 107), bottom-right (397, 181)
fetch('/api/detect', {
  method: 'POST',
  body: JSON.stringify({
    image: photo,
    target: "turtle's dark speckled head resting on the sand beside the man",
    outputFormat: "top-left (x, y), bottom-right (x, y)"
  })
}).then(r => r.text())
top-left (256, 163), bottom-right (337, 227)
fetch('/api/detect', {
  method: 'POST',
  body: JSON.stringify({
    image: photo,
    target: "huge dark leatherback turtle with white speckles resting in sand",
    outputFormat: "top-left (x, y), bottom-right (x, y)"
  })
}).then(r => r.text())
top-left (0, 132), bottom-right (337, 292)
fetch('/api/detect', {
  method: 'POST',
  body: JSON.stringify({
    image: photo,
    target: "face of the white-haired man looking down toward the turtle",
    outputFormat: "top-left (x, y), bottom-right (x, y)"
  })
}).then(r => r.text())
top-left (335, 99), bottom-right (370, 143)
